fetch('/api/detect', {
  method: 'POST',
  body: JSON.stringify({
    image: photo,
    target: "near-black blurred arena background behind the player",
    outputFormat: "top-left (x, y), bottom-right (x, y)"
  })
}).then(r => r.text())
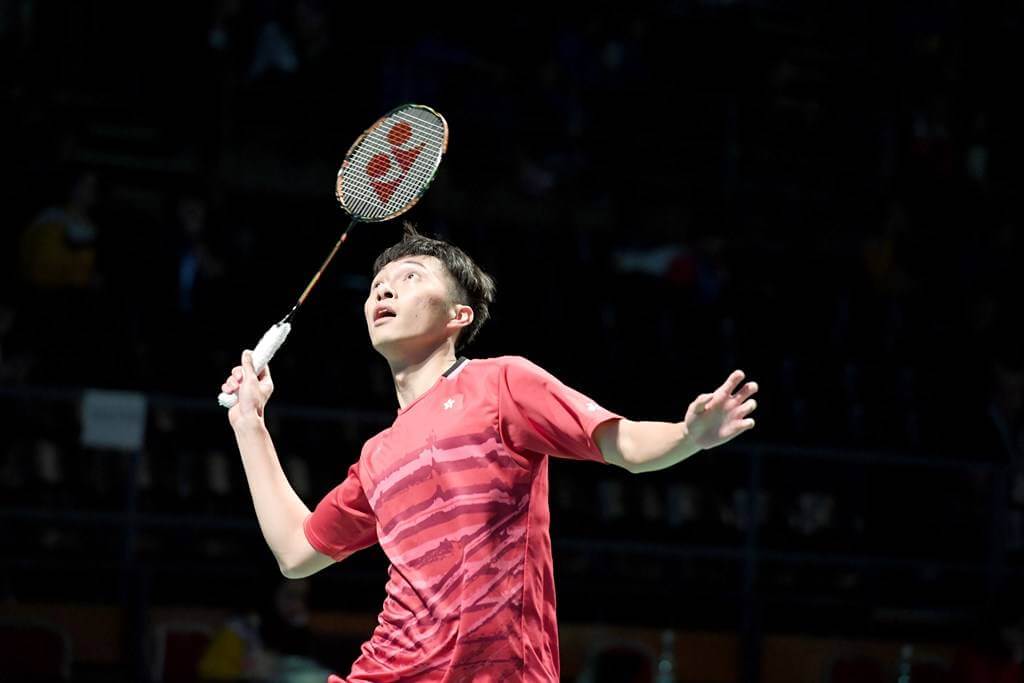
top-left (0, 0), bottom-right (1024, 680)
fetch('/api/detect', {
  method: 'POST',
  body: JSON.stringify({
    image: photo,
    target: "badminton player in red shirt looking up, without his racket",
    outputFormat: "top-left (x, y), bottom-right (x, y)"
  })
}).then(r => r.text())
top-left (222, 224), bottom-right (757, 683)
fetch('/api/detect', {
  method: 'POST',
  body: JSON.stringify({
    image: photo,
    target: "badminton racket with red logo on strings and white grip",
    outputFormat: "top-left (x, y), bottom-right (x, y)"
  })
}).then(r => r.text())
top-left (217, 104), bottom-right (449, 408)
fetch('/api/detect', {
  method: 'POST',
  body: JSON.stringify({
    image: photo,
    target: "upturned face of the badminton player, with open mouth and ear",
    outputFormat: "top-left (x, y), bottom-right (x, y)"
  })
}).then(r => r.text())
top-left (362, 256), bottom-right (473, 357)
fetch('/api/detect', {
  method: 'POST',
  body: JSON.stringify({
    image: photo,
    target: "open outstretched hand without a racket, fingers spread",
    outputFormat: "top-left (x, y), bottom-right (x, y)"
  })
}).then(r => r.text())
top-left (685, 370), bottom-right (758, 449)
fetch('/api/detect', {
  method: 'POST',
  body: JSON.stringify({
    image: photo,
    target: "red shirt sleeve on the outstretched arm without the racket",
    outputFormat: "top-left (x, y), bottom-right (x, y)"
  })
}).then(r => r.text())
top-left (498, 356), bottom-right (622, 463)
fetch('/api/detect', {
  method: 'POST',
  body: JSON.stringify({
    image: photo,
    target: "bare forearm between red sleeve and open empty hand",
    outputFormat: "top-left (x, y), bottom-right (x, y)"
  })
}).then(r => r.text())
top-left (597, 419), bottom-right (700, 473)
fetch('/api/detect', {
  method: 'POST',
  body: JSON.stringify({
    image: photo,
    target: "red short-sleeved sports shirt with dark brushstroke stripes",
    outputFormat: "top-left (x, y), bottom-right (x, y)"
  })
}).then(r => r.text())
top-left (304, 356), bottom-right (621, 683)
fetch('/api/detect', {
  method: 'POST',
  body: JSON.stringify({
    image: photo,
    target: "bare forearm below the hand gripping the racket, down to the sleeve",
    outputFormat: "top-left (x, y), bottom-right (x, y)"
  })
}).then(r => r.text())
top-left (234, 419), bottom-right (309, 571)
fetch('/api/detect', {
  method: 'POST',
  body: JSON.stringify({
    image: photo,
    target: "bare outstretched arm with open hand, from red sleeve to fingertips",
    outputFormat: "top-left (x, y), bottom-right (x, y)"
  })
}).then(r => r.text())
top-left (594, 370), bottom-right (758, 473)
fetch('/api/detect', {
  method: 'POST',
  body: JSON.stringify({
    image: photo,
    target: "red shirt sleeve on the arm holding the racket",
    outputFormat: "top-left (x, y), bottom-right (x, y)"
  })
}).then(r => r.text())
top-left (302, 463), bottom-right (377, 562)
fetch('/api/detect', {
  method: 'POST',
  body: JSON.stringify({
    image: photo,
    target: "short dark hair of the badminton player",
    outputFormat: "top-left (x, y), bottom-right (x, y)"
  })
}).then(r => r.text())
top-left (373, 220), bottom-right (495, 353)
